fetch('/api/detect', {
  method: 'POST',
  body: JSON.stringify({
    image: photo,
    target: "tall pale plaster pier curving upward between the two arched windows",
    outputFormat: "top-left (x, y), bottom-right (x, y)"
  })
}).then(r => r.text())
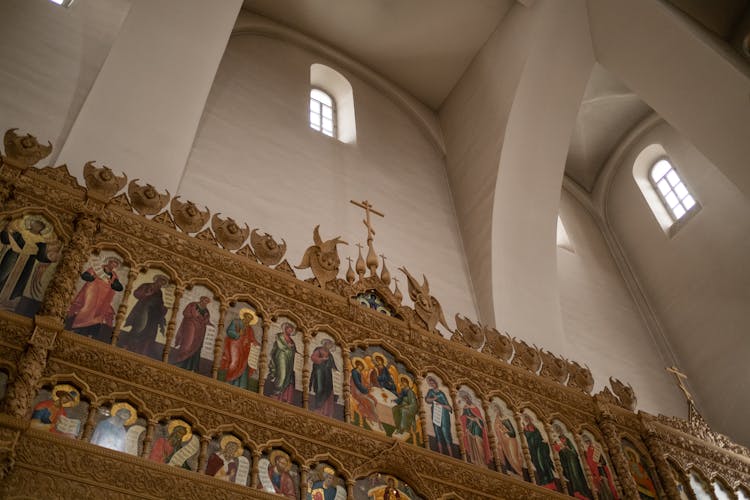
top-left (440, 0), bottom-right (594, 352)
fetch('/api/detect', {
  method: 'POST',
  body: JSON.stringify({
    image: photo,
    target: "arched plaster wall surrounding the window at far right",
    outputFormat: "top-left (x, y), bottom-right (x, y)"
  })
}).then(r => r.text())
top-left (606, 123), bottom-right (750, 444)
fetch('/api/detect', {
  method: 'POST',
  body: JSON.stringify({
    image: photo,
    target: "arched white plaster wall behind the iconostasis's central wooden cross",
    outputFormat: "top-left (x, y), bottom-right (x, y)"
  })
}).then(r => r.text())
top-left (178, 33), bottom-right (476, 326)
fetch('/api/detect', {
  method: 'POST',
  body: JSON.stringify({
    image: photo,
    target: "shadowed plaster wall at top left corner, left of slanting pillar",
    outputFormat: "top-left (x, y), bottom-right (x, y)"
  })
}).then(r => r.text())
top-left (0, 0), bottom-right (131, 160)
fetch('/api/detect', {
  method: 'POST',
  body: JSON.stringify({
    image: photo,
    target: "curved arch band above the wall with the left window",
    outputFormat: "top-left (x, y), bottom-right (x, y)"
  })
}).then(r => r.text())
top-left (232, 13), bottom-right (446, 155)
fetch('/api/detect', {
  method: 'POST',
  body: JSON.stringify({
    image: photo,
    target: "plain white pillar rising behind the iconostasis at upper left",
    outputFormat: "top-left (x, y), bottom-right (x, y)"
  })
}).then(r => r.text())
top-left (56, 0), bottom-right (242, 193)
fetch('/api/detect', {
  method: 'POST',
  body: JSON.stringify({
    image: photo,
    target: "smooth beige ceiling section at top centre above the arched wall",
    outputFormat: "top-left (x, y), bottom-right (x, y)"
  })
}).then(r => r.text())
top-left (244, 0), bottom-right (515, 109)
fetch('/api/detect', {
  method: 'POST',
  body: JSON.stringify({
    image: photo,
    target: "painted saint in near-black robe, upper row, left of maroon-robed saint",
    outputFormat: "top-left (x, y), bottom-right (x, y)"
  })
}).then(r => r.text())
top-left (120, 274), bottom-right (169, 359)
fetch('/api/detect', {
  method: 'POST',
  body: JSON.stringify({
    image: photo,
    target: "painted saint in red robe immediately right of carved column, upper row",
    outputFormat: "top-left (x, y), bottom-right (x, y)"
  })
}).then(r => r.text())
top-left (65, 257), bottom-right (124, 342)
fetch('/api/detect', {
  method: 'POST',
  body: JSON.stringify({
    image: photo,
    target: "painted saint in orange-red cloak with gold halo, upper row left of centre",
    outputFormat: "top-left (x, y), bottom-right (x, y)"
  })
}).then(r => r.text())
top-left (218, 308), bottom-right (260, 389)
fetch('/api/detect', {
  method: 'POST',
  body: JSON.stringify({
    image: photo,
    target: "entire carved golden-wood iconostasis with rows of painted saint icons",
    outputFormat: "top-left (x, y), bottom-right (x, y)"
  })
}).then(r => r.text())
top-left (0, 130), bottom-right (750, 500)
